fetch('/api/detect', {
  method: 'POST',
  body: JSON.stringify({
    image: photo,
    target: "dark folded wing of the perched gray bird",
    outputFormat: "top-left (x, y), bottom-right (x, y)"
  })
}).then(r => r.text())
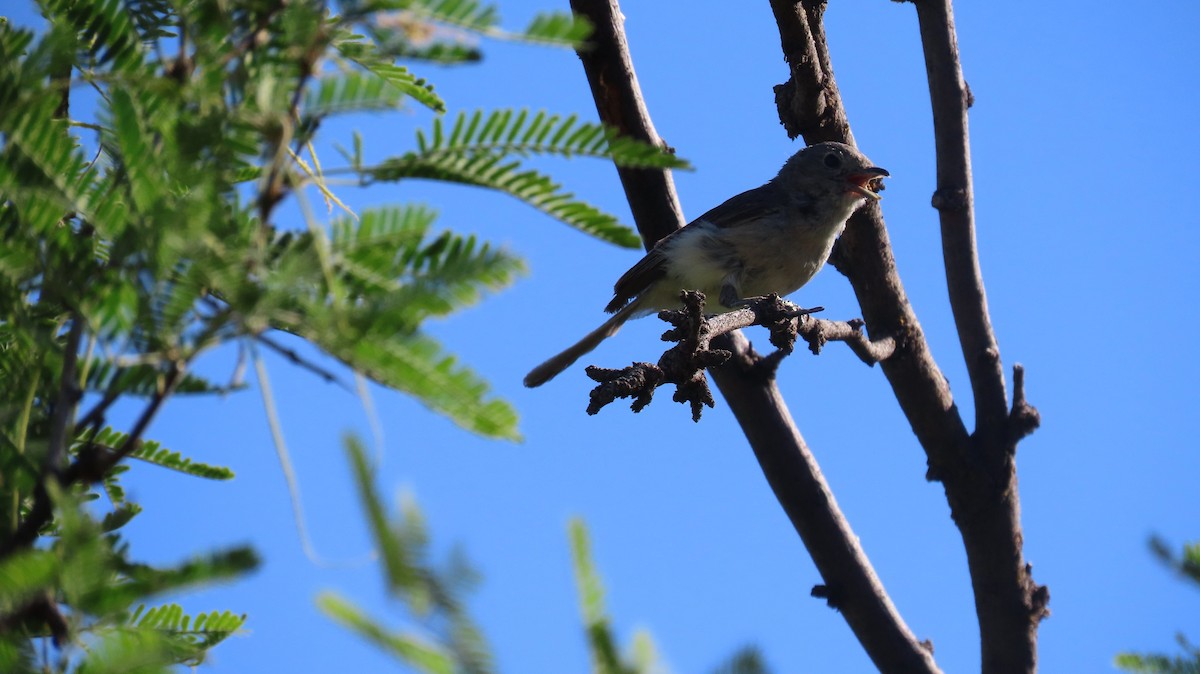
top-left (605, 182), bottom-right (780, 313)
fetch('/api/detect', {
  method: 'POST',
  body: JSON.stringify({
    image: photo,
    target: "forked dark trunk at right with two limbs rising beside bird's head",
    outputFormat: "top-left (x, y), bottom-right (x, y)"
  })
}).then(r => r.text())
top-left (772, 0), bottom-right (1049, 673)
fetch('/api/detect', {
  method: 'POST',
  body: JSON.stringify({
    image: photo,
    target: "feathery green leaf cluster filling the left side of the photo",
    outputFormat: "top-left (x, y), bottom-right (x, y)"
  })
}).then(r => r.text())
top-left (0, 0), bottom-right (684, 672)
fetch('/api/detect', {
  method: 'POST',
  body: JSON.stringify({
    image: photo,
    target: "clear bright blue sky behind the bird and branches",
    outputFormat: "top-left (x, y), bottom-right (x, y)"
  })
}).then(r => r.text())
top-left (9, 0), bottom-right (1200, 673)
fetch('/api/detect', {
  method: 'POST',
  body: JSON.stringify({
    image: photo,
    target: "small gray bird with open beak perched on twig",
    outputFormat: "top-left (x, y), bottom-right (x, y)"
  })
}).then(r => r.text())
top-left (524, 143), bottom-right (888, 387)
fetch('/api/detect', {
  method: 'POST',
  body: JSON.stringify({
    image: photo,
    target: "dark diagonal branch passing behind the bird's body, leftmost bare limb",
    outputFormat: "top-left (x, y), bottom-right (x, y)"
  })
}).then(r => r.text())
top-left (571, 0), bottom-right (948, 672)
